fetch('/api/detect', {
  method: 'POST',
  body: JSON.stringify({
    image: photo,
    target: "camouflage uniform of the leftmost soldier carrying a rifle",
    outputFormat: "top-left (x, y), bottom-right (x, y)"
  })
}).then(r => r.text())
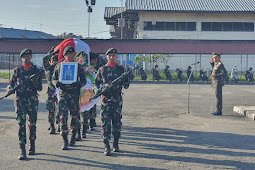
top-left (7, 63), bottom-right (42, 144)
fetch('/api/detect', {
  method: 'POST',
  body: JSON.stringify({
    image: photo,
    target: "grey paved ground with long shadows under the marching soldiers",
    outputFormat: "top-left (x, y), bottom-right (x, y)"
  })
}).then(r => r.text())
top-left (0, 81), bottom-right (255, 170)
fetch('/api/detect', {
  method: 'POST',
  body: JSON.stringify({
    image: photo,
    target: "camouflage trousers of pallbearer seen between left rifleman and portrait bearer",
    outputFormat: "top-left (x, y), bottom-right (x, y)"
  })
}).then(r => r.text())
top-left (46, 94), bottom-right (60, 123)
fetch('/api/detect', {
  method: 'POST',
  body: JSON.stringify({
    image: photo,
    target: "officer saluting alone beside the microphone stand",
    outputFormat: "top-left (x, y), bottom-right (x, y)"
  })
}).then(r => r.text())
top-left (211, 53), bottom-right (227, 115)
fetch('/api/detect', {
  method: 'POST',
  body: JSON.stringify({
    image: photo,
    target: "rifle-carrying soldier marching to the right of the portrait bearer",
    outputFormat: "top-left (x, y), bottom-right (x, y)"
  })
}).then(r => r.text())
top-left (94, 48), bottom-right (129, 156)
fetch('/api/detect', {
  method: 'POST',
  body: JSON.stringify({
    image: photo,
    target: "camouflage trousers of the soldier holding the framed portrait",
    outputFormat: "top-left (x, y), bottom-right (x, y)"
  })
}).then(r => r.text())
top-left (58, 93), bottom-right (80, 136)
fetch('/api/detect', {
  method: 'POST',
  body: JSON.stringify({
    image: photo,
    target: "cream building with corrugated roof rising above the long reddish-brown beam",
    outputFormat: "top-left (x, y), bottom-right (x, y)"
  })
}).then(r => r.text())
top-left (104, 0), bottom-right (255, 40)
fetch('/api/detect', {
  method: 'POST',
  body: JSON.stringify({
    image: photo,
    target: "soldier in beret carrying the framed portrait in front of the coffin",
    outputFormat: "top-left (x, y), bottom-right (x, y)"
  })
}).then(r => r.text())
top-left (52, 46), bottom-right (86, 150)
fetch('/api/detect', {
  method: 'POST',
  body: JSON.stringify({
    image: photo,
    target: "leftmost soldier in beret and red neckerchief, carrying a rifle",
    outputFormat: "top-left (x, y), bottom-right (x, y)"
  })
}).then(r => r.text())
top-left (7, 48), bottom-right (42, 160)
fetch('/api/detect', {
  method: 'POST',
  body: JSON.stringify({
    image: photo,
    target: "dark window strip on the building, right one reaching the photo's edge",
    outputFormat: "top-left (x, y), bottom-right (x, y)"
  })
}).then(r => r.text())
top-left (201, 22), bottom-right (254, 32)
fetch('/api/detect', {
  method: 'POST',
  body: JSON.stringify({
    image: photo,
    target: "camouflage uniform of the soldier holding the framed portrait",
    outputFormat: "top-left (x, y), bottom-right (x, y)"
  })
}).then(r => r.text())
top-left (52, 63), bottom-right (86, 136)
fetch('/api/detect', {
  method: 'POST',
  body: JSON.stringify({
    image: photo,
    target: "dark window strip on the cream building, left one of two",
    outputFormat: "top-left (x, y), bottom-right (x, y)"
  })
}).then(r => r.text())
top-left (144, 21), bottom-right (196, 31)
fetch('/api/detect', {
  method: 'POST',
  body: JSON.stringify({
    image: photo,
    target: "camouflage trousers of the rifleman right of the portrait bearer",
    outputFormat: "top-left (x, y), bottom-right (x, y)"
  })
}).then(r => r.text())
top-left (100, 96), bottom-right (122, 142)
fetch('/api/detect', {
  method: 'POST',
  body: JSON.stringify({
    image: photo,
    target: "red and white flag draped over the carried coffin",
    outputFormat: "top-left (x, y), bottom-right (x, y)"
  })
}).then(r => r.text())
top-left (54, 38), bottom-right (90, 65)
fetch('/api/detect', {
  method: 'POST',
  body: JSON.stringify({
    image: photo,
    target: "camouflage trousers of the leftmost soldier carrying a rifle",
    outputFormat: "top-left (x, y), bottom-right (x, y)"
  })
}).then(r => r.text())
top-left (14, 96), bottom-right (39, 144)
